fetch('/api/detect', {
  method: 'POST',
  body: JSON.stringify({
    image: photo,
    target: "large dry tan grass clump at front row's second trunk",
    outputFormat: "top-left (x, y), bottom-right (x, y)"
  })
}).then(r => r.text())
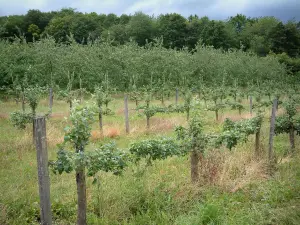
top-left (200, 150), bottom-right (268, 192)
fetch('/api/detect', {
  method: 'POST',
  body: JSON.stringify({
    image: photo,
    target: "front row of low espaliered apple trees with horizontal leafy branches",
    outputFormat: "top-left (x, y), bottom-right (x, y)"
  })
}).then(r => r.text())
top-left (47, 92), bottom-right (300, 224)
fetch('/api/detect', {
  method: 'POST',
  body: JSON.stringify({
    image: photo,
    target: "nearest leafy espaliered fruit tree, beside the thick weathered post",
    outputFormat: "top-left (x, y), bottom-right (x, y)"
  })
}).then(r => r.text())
top-left (50, 101), bottom-right (128, 225)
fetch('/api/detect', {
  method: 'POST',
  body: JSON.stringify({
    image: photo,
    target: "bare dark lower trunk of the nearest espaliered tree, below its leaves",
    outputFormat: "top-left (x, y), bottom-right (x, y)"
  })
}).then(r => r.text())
top-left (76, 168), bottom-right (86, 225)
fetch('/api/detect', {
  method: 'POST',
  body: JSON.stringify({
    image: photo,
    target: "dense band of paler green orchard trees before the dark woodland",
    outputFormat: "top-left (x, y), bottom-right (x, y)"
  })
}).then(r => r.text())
top-left (0, 37), bottom-right (290, 92)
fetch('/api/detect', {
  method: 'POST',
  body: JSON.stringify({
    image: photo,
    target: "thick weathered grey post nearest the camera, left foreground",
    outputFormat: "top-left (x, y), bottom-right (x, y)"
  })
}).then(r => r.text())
top-left (33, 117), bottom-right (52, 225)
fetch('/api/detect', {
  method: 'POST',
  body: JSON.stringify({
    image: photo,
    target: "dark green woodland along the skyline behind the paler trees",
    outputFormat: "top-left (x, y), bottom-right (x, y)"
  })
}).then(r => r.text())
top-left (0, 8), bottom-right (300, 58)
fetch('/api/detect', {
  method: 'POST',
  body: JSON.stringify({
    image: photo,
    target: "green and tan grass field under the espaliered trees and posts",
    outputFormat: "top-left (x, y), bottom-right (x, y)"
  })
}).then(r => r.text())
top-left (0, 98), bottom-right (300, 225)
